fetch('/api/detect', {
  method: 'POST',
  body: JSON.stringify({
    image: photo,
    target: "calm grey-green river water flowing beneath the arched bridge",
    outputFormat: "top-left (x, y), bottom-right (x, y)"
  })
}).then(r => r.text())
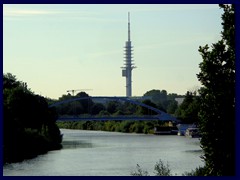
top-left (3, 129), bottom-right (203, 176)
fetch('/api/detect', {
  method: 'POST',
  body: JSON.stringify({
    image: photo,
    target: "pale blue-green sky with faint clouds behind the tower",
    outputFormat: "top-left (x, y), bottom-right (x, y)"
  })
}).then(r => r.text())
top-left (3, 4), bottom-right (222, 98)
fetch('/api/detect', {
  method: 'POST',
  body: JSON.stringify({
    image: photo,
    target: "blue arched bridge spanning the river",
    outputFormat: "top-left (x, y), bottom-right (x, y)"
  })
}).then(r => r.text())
top-left (49, 96), bottom-right (179, 122)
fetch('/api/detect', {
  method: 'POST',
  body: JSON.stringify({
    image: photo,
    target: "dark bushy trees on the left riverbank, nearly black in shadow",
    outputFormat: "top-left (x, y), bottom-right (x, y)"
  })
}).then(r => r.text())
top-left (3, 73), bottom-right (62, 164)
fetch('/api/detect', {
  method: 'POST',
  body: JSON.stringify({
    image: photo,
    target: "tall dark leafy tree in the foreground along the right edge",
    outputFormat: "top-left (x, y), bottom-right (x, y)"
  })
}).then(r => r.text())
top-left (197, 5), bottom-right (235, 175)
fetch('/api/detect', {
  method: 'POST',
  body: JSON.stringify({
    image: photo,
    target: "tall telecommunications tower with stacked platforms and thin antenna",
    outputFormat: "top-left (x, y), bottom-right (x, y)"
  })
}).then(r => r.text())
top-left (122, 12), bottom-right (136, 97)
